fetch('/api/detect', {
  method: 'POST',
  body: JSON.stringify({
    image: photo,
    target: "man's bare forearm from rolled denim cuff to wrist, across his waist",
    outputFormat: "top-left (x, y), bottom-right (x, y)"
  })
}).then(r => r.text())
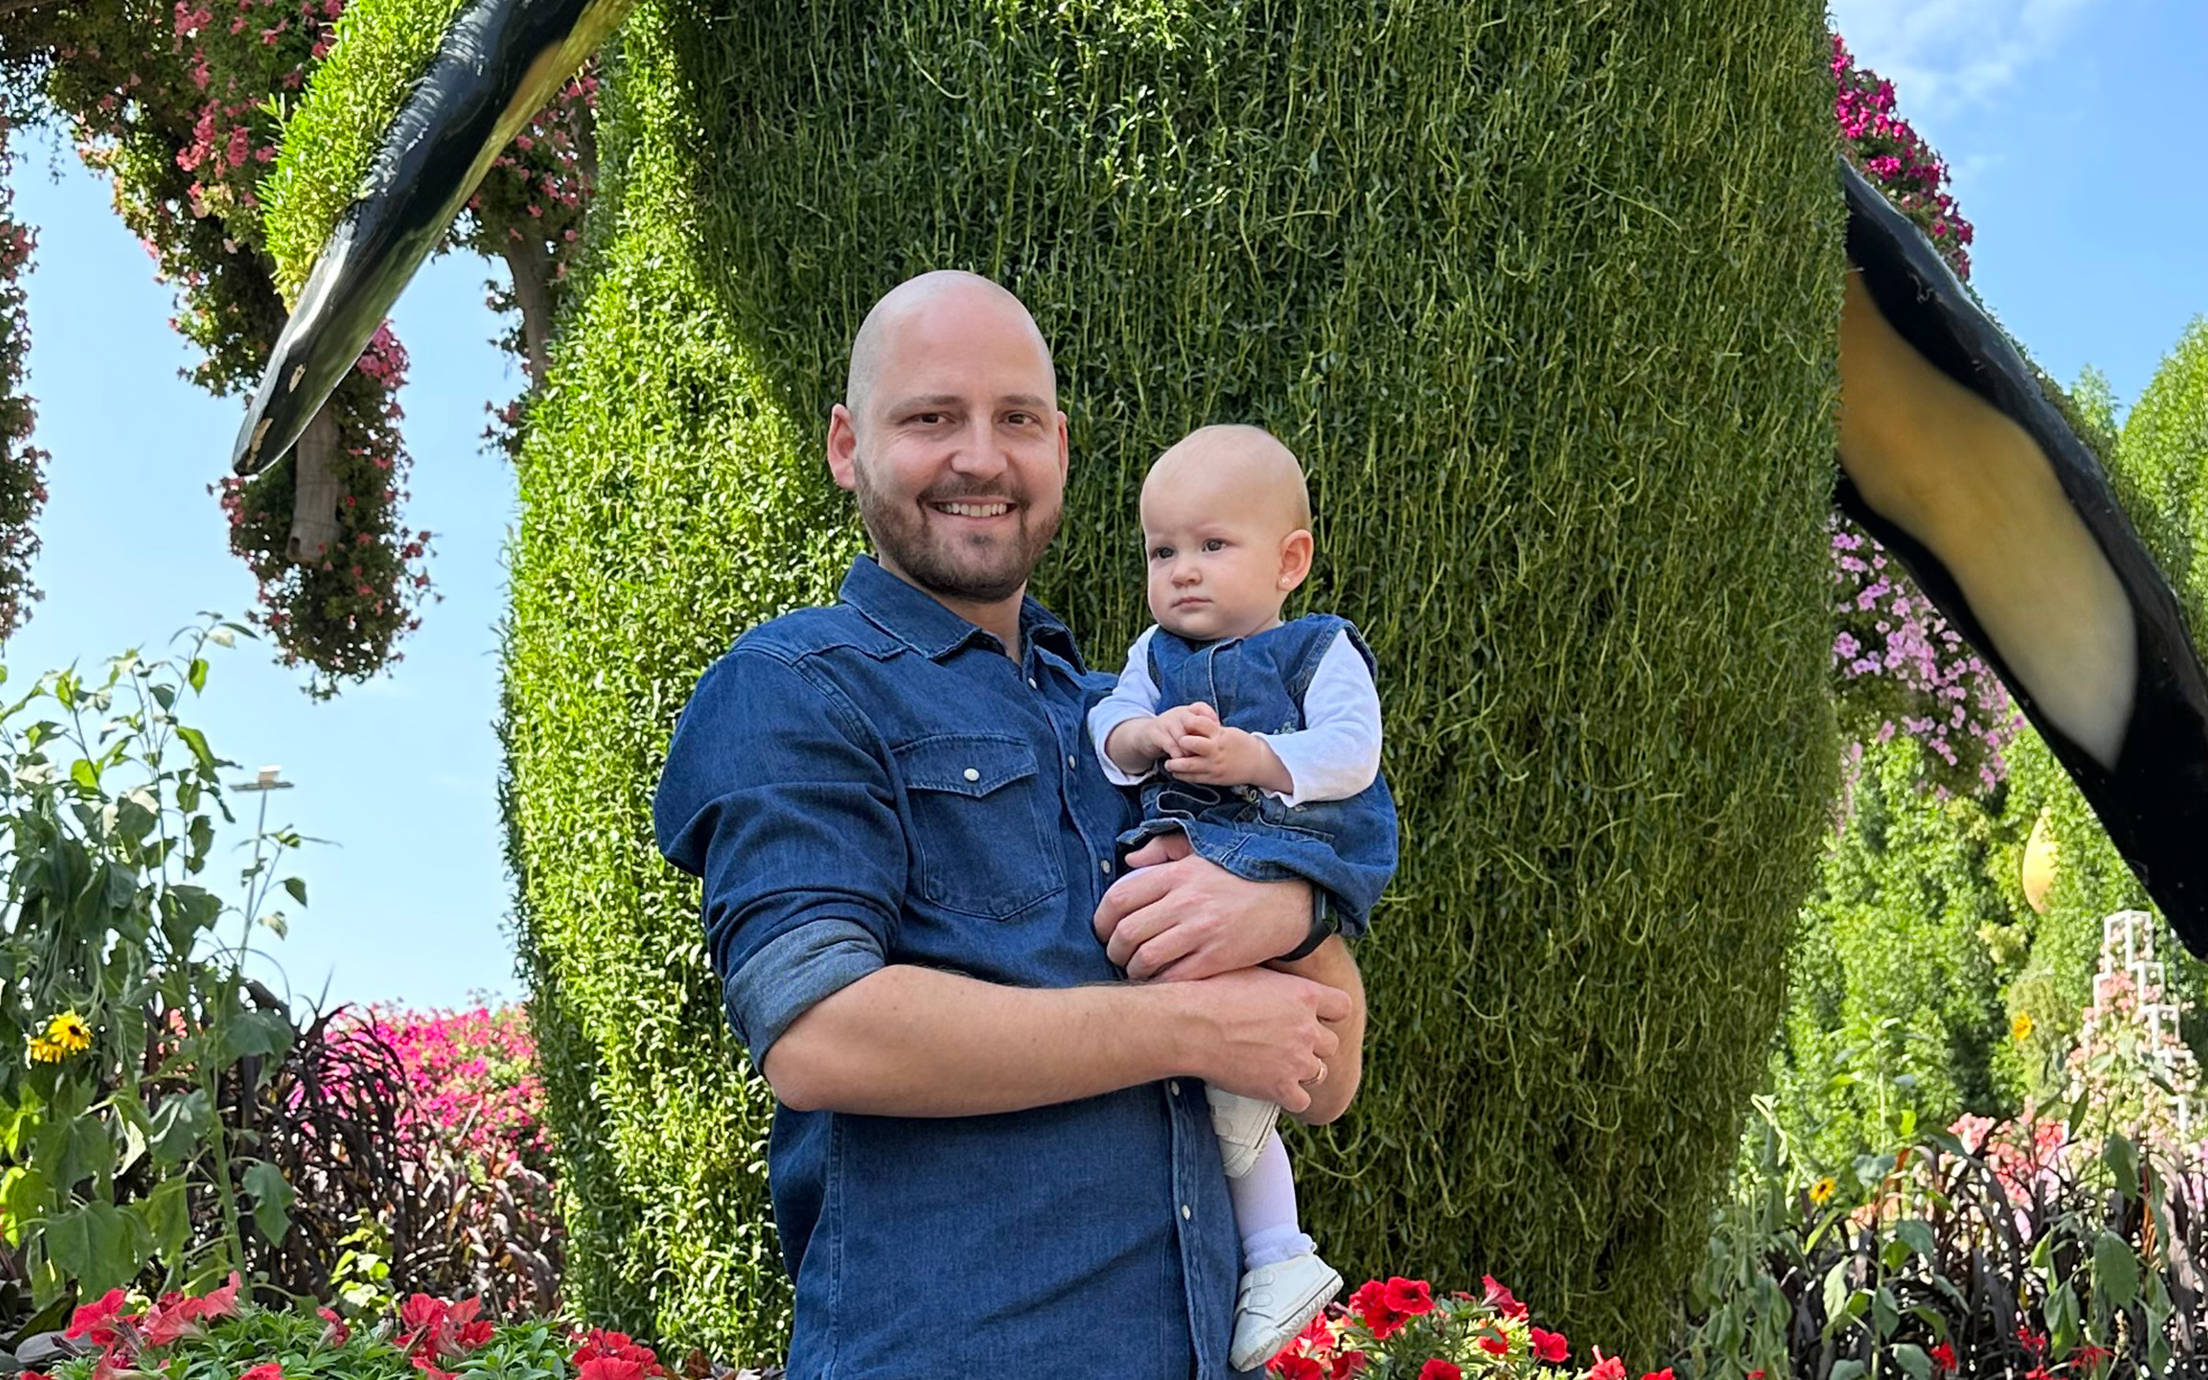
top-left (760, 954), bottom-right (1192, 1117)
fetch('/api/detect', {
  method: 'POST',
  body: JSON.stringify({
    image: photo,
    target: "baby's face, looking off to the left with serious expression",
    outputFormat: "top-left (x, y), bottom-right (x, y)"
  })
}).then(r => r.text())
top-left (1142, 441), bottom-right (1301, 640)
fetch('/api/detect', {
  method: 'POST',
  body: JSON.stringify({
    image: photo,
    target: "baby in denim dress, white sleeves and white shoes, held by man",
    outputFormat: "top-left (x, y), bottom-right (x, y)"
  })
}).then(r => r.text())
top-left (1089, 426), bottom-right (1395, 1369)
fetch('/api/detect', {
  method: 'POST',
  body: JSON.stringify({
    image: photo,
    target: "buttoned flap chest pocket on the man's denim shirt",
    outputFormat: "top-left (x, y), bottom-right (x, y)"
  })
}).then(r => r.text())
top-left (892, 733), bottom-right (1066, 921)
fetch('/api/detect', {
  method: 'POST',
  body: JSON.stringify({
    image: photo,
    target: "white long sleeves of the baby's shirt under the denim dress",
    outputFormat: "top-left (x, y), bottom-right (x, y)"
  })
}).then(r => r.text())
top-left (1089, 625), bottom-right (1380, 806)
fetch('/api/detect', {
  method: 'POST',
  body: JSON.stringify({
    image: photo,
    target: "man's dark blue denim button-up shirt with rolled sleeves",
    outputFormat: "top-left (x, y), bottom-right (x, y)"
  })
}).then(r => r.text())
top-left (654, 556), bottom-right (1239, 1380)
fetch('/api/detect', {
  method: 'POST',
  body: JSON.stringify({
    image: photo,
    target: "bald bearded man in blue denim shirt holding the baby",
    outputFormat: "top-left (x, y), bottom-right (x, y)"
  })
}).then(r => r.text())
top-left (654, 274), bottom-right (1365, 1380)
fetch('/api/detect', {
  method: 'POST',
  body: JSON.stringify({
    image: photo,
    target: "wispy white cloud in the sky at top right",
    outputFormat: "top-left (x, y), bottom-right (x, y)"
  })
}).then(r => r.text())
top-left (1828, 0), bottom-right (2104, 121)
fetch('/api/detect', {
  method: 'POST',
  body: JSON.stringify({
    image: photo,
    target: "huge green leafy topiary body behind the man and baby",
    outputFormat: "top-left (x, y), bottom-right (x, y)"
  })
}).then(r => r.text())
top-left (503, 0), bottom-right (1841, 1358)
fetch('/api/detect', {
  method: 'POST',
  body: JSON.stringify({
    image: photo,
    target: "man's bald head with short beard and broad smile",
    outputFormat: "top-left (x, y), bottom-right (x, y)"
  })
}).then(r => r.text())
top-left (828, 274), bottom-right (1066, 603)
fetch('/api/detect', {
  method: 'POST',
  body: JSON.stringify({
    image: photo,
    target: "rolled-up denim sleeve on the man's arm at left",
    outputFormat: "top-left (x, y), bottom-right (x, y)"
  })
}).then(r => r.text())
top-left (651, 645), bottom-right (905, 1064)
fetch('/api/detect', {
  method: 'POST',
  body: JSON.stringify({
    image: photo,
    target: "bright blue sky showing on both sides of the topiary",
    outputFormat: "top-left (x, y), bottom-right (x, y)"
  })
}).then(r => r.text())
top-left (4, 0), bottom-right (2208, 1007)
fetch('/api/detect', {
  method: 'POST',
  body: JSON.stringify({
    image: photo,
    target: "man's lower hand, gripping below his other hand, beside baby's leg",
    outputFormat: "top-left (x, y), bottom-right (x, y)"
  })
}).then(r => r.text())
top-left (1172, 967), bottom-right (1351, 1113)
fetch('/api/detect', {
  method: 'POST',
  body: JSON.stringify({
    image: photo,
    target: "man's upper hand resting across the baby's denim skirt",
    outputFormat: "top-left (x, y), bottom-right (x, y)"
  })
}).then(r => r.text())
top-left (1095, 835), bottom-right (1312, 980)
